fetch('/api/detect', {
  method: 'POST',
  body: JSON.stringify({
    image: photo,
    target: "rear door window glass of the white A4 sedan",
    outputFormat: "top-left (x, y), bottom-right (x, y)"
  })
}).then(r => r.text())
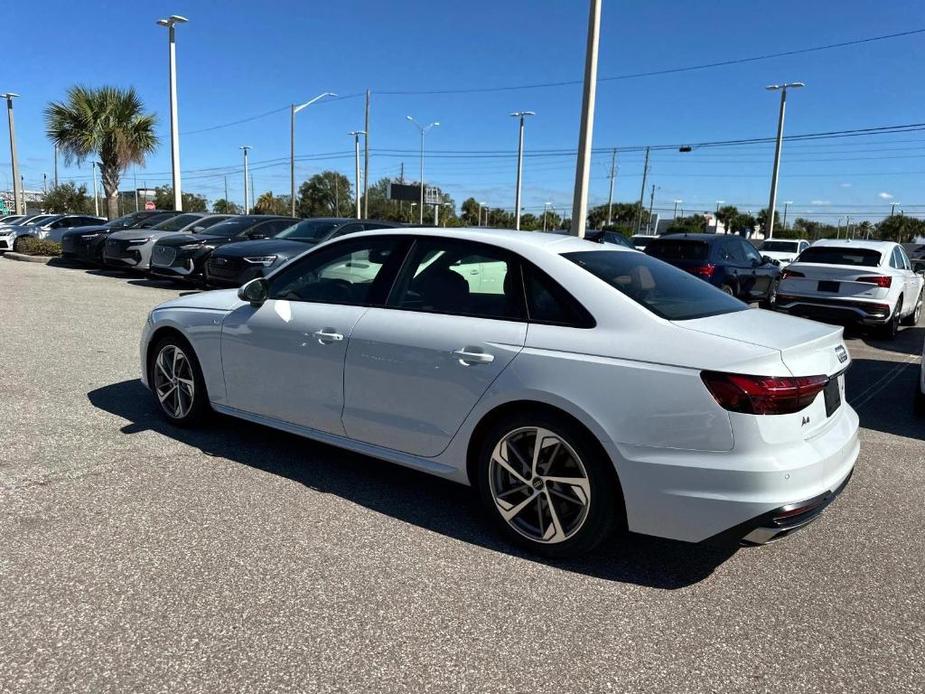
top-left (389, 237), bottom-right (525, 320)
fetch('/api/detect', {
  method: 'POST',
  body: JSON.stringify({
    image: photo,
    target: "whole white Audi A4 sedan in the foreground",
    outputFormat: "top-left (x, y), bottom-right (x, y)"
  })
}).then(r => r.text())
top-left (141, 229), bottom-right (859, 556)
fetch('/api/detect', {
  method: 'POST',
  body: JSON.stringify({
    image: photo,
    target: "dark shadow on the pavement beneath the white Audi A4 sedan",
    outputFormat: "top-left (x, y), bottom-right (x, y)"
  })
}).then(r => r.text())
top-left (87, 380), bottom-right (738, 590)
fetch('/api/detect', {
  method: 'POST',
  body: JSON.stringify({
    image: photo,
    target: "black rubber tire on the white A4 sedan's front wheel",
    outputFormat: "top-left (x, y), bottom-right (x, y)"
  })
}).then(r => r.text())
top-left (148, 335), bottom-right (209, 427)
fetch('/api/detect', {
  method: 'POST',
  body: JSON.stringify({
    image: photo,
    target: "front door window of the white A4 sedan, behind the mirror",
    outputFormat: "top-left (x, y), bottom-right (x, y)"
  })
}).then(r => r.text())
top-left (269, 236), bottom-right (403, 306)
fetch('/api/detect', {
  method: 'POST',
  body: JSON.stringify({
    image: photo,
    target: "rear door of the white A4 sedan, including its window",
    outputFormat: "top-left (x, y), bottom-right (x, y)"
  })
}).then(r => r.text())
top-left (343, 237), bottom-right (527, 457)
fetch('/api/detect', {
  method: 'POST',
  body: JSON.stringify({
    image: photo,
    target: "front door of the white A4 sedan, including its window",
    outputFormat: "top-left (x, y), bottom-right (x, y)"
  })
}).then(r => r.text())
top-left (222, 236), bottom-right (401, 434)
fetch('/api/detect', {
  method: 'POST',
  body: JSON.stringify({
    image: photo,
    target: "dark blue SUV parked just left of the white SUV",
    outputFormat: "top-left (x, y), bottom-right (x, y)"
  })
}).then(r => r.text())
top-left (645, 234), bottom-right (780, 306)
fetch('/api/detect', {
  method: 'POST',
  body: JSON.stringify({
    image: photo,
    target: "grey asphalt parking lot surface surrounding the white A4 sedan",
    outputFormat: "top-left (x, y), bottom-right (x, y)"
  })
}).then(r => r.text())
top-left (0, 259), bottom-right (925, 692)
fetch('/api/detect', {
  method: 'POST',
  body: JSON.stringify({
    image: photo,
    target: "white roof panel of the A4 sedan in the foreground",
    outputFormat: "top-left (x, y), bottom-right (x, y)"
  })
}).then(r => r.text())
top-left (326, 227), bottom-right (635, 254)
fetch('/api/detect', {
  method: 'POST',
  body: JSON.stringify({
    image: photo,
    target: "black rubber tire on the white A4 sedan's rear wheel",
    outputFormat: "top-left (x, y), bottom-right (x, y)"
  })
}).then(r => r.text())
top-left (475, 410), bottom-right (626, 558)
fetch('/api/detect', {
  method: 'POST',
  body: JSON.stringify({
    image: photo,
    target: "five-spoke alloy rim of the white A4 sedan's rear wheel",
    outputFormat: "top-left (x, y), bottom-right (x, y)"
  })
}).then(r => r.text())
top-left (488, 427), bottom-right (591, 544)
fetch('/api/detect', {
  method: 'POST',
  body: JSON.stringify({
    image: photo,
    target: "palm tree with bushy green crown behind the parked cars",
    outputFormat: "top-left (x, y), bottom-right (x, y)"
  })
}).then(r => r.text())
top-left (45, 86), bottom-right (158, 219)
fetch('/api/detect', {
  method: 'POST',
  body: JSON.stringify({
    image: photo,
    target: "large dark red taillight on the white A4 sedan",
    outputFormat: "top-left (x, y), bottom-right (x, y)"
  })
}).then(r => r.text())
top-left (700, 371), bottom-right (829, 414)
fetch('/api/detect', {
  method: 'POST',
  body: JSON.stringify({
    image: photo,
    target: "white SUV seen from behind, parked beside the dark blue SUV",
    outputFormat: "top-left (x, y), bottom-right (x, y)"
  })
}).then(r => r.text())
top-left (775, 239), bottom-right (925, 339)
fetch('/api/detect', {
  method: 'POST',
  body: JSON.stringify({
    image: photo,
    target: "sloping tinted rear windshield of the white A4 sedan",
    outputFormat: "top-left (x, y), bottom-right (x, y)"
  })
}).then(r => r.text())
top-left (563, 250), bottom-right (748, 320)
